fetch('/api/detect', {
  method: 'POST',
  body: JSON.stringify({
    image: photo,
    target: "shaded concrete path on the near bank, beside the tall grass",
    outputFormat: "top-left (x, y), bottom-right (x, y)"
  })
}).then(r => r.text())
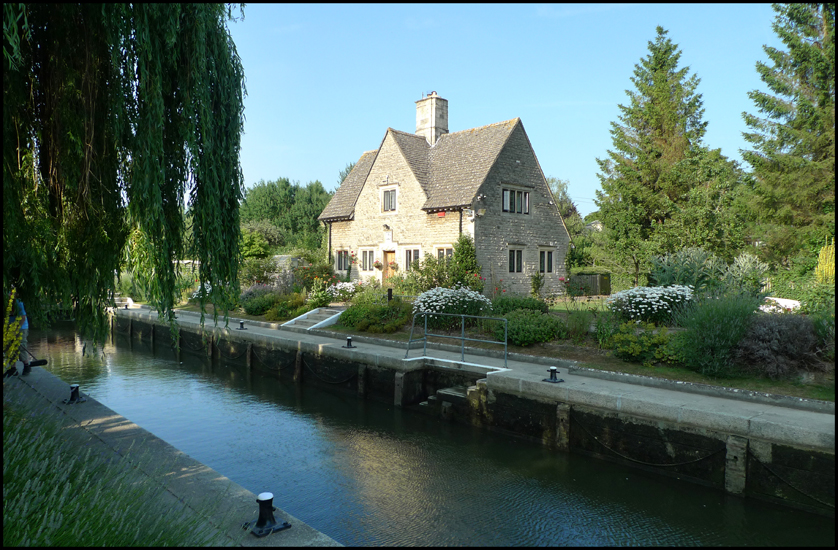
top-left (3, 367), bottom-right (341, 547)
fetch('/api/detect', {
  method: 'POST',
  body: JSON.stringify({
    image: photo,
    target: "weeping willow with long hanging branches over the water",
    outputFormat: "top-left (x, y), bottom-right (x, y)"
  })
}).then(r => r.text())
top-left (3, 4), bottom-right (245, 338)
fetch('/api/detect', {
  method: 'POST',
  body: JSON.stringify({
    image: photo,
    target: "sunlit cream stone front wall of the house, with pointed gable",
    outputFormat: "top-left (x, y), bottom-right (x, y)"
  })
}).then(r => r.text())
top-left (332, 133), bottom-right (468, 280)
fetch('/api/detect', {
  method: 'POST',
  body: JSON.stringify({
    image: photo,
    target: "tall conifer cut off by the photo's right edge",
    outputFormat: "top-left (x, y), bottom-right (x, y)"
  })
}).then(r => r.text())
top-left (742, 3), bottom-right (835, 264)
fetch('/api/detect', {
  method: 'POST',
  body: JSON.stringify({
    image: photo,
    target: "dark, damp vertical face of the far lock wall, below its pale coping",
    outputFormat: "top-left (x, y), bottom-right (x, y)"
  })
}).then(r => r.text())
top-left (112, 316), bottom-right (835, 515)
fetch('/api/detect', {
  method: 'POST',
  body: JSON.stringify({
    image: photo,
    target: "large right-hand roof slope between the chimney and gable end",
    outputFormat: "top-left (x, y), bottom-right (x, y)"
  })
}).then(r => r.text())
top-left (422, 118), bottom-right (520, 210)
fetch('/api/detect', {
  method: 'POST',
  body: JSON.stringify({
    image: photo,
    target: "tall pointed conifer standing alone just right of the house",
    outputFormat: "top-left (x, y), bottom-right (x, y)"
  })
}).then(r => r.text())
top-left (596, 27), bottom-right (707, 284)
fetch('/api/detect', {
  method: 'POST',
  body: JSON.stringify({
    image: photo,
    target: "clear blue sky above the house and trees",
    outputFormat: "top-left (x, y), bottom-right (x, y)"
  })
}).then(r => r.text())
top-left (229, 4), bottom-right (782, 220)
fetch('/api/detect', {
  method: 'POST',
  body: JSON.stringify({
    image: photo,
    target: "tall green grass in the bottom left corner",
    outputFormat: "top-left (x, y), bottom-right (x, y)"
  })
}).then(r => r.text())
top-left (3, 397), bottom-right (244, 547)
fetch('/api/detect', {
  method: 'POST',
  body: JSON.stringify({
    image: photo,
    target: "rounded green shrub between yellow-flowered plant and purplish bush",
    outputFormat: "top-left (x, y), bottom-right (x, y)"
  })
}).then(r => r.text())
top-left (674, 292), bottom-right (762, 376)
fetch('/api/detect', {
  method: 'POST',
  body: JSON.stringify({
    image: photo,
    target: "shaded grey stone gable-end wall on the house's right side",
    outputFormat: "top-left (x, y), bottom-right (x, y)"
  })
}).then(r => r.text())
top-left (474, 124), bottom-right (570, 300)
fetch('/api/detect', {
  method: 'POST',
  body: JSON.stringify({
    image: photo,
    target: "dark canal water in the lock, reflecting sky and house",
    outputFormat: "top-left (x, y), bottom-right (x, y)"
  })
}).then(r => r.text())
top-left (29, 326), bottom-right (835, 546)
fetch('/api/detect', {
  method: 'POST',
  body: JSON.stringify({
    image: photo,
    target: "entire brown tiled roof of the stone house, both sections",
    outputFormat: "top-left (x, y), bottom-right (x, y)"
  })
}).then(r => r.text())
top-left (317, 118), bottom-right (520, 221)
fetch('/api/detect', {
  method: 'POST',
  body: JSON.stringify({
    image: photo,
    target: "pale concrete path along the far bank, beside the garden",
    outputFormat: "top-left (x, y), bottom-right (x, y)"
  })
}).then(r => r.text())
top-left (128, 309), bottom-right (835, 453)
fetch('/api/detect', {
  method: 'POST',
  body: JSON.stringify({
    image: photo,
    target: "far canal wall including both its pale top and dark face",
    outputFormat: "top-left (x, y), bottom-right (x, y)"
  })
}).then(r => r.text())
top-left (112, 310), bottom-right (835, 515)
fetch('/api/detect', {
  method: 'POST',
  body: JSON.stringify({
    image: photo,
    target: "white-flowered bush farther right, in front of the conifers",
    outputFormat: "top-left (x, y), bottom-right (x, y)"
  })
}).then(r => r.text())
top-left (605, 285), bottom-right (693, 325)
